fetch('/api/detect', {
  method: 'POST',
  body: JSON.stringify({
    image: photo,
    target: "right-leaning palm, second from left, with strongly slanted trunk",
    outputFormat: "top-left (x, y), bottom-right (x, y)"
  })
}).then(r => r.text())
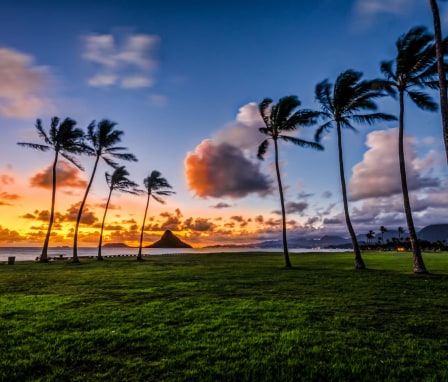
top-left (72, 119), bottom-right (137, 263)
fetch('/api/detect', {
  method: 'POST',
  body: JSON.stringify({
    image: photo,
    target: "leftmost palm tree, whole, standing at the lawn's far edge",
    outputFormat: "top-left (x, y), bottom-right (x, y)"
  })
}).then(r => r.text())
top-left (17, 117), bottom-right (84, 262)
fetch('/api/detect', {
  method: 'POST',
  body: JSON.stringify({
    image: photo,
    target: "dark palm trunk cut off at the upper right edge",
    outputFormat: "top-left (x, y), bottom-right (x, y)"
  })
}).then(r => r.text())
top-left (429, 0), bottom-right (448, 163)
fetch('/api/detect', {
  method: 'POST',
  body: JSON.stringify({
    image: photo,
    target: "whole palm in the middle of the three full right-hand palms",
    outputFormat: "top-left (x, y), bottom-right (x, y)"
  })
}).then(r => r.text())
top-left (316, 69), bottom-right (396, 269)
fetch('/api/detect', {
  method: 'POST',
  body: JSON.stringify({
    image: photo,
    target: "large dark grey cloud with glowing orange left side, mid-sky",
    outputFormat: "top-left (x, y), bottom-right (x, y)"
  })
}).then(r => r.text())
top-left (185, 140), bottom-right (271, 198)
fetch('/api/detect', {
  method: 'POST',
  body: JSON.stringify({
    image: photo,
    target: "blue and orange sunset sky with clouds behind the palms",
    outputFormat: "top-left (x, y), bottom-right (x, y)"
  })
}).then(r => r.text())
top-left (0, 0), bottom-right (448, 247)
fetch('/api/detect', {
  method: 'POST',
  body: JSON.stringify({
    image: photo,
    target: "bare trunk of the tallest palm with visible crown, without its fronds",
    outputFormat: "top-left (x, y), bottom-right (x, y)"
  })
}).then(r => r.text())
top-left (398, 90), bottom-right (427, 273)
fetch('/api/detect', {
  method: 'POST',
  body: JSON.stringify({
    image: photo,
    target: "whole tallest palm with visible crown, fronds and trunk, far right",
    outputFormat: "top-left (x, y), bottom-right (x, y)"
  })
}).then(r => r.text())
top-left (381, 27), bottom-right (438, 273)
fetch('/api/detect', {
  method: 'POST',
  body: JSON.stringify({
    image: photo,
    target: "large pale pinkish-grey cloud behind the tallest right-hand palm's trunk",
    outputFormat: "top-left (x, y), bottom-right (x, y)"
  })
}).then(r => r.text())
top-left (348, 128), bottom-right (440, 200)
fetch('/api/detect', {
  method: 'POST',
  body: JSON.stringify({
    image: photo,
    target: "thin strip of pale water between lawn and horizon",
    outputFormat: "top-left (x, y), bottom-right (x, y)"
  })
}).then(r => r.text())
top-left (0, 247), bottom-right (344, 262)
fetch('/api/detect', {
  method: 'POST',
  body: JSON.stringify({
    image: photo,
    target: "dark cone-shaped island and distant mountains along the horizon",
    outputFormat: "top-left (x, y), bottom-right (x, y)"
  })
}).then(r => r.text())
top-left (104, 224), bottom-right (448, 249)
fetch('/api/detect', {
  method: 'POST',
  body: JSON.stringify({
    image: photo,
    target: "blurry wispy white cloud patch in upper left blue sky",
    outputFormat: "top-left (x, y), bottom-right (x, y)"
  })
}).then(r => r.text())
top-left (82, 34), bottom-right (160, 89)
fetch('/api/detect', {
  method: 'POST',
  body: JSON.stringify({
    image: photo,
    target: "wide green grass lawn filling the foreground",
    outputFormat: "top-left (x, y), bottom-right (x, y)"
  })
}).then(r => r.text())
top-left (0, 252), bottom-right (448, 382)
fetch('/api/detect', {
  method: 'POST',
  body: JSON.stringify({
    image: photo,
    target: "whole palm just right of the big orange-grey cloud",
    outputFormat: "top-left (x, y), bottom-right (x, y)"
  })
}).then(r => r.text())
top-left (258, 95), bottom-right (323, 268)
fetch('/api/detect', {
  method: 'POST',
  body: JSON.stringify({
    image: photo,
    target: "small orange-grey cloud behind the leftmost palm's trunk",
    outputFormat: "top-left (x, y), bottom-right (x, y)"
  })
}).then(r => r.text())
top-left (30, 161), bottom-right (87, 189)
